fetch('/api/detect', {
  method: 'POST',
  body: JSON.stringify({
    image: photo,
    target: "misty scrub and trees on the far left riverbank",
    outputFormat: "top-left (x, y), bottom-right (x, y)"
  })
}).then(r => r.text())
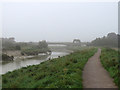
top-left (2, 38), bottom-right (51, 55)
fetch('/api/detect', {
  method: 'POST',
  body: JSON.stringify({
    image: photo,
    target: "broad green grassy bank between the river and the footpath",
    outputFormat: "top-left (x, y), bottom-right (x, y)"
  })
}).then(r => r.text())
top-left (2, 48), bottom-right (97, 88)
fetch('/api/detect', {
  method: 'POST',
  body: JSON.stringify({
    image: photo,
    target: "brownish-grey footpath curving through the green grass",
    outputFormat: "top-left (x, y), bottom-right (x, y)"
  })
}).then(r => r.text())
top-left (83, 49), bottom-right (117, 88)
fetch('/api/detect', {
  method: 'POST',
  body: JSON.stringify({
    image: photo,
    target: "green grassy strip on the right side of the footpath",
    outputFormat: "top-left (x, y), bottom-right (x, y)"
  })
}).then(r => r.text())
top-left (101, 48), bottom-right (120, 88)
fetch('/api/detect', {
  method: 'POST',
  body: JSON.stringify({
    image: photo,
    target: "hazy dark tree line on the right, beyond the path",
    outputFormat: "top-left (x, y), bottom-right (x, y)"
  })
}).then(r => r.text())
top-left (88, 33), bottom-right (120, 47)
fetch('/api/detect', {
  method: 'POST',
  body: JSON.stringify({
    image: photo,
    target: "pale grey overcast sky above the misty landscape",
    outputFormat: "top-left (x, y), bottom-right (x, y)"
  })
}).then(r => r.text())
top-left (2, 2), bottom-right (118, 41)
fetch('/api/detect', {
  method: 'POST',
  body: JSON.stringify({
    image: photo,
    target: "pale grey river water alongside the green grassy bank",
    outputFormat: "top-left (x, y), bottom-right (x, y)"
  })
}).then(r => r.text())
top-left (0, 52), bottom-right (69, 74)
